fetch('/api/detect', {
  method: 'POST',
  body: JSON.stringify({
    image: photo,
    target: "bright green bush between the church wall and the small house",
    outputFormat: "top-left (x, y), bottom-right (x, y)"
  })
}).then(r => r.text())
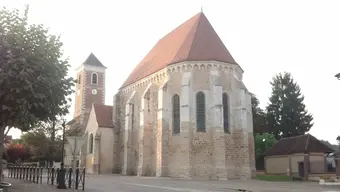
top-left (255, 133), bottom-right (276, 170)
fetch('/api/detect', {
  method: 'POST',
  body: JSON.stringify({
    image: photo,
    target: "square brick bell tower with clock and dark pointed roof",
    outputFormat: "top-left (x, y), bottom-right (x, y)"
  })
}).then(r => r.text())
top-left (74, 53), bottom-right (106, 129)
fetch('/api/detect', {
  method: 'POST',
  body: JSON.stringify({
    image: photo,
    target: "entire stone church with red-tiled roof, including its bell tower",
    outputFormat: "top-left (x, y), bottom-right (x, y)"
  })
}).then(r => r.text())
top-left (65, 12), bottom-right (255, 179)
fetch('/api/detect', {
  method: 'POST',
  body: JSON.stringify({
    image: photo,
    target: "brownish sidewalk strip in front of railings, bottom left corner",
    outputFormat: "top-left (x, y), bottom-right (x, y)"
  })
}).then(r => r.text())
top-left (5, 178), bottom-right (72, 192)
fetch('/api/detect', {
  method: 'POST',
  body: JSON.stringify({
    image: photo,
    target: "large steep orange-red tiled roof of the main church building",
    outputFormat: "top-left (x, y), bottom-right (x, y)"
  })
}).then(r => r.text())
top-left (122, 12), bottom-right (237, 88)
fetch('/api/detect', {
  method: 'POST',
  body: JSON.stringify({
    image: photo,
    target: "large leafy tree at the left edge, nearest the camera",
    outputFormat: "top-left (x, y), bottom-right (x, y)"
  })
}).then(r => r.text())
top-left (0, 6), bottom-right (74, 177)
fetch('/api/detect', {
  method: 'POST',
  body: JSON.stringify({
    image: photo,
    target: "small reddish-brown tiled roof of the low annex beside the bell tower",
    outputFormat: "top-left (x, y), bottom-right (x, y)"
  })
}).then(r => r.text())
top-left (93, 104), bottom-right (113, 128)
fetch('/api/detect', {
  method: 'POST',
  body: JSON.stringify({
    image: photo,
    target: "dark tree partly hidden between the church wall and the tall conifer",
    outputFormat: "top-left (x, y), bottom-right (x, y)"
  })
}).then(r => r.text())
top-left (251, 94), bottom-right (268, 135)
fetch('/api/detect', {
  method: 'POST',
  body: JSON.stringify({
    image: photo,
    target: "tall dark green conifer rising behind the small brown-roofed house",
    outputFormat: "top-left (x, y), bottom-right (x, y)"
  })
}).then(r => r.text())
top-left (267, 72), bottom-right (313, 139)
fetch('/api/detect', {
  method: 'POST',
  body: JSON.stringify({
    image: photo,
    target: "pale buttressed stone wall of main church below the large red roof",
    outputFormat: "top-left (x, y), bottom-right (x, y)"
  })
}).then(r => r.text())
top-left (117, 62), bottom-right (255, 179)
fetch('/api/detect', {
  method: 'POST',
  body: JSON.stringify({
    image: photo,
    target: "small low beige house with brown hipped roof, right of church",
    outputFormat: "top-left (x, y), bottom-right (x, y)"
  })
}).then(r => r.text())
top-left (265, 134), bottom-right (334, 177)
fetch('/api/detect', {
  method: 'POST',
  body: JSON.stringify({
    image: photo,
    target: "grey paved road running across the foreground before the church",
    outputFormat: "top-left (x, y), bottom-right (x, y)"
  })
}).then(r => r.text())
top-left (85, 175), bottom-right (340, 192)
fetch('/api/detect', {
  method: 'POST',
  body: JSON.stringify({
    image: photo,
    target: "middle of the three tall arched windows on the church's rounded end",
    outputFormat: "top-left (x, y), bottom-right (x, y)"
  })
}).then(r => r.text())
top-left (196, 91), bottom-right (205, 132)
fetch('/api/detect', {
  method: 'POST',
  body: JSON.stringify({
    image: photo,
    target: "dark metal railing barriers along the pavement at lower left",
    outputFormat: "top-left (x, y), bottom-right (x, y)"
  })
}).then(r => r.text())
top-left (8, 166), bottom-right (85, 191)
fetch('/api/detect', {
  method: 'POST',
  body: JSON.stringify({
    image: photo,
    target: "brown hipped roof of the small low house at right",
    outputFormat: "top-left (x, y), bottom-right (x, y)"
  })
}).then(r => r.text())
top-left (264, 134), bottom-right (334, 156)
